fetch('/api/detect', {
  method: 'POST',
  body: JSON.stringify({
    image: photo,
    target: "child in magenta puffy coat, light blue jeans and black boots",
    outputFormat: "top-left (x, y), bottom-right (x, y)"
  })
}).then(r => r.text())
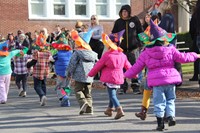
top-left (125, 20), bottom-right (200, 131)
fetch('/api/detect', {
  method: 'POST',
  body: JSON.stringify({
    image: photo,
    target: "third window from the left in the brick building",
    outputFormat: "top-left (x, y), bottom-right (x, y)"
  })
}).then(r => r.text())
top-left (75, 0), bottom-right (87, 15)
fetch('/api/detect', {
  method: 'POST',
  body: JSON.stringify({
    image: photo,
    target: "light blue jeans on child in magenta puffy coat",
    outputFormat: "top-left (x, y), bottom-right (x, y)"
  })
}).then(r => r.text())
top-left (153, 85), bottom-right (176, 118)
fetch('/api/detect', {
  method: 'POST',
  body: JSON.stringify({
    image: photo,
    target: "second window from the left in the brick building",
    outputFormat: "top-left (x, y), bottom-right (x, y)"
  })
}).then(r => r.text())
top-left (53, 0), bottom-right (65, 15)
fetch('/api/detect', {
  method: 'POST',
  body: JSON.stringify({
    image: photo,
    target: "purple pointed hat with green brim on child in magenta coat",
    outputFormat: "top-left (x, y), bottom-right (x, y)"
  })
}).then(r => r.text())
top-left (138, 20), bottom-right (176, 46)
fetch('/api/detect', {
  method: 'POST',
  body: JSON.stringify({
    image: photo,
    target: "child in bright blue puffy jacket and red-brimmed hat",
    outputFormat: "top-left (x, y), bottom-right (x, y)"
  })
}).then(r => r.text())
top-left (52, 33), bottom-right (72, 107)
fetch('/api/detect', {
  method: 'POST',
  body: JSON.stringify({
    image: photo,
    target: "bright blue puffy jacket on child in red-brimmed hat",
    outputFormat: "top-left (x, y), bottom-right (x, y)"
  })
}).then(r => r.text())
top-left (53, 50), bottom-right (72, 77)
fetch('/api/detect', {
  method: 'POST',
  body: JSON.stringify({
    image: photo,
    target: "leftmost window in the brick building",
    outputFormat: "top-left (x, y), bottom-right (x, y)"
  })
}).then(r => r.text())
top-left (31, 0), bottom-right (44, 16)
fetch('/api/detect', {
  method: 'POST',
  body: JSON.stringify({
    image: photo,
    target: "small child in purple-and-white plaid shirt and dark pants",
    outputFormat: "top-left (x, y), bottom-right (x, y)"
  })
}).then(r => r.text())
top-left (14, 46), bottom-right (31, 97)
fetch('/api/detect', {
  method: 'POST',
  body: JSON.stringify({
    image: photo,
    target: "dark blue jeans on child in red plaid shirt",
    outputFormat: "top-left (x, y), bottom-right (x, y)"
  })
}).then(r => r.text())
top-left (33, 77), bottom-right (46, 100)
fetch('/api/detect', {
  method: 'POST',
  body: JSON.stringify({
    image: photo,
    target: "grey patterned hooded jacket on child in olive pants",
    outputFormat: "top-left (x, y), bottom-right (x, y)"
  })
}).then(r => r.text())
top-left (66, 50), bottom-right (98, 83)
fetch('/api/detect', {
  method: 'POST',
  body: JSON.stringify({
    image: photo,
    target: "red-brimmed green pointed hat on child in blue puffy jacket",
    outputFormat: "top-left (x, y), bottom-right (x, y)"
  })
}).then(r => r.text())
top-left (52, 34), bottom-right (72, 51)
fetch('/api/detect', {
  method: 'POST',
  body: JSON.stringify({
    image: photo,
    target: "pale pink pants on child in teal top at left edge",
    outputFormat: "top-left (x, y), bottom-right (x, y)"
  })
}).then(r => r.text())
top-left (0, 74), bottom-right (11, 102)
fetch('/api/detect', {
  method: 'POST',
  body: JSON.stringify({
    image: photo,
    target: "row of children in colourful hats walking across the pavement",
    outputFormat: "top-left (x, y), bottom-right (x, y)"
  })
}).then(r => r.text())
top-left (0, 18), bottom-right (200, 131)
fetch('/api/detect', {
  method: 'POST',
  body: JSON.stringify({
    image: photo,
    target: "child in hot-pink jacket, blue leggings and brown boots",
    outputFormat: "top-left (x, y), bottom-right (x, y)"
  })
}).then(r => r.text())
top-left (88, 30), bottom-right (131, 119)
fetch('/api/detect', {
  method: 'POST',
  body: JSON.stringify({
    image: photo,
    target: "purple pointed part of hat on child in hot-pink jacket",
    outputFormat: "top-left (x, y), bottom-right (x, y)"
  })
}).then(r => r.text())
top-left (108, 29), bottom-right (125, 46)
